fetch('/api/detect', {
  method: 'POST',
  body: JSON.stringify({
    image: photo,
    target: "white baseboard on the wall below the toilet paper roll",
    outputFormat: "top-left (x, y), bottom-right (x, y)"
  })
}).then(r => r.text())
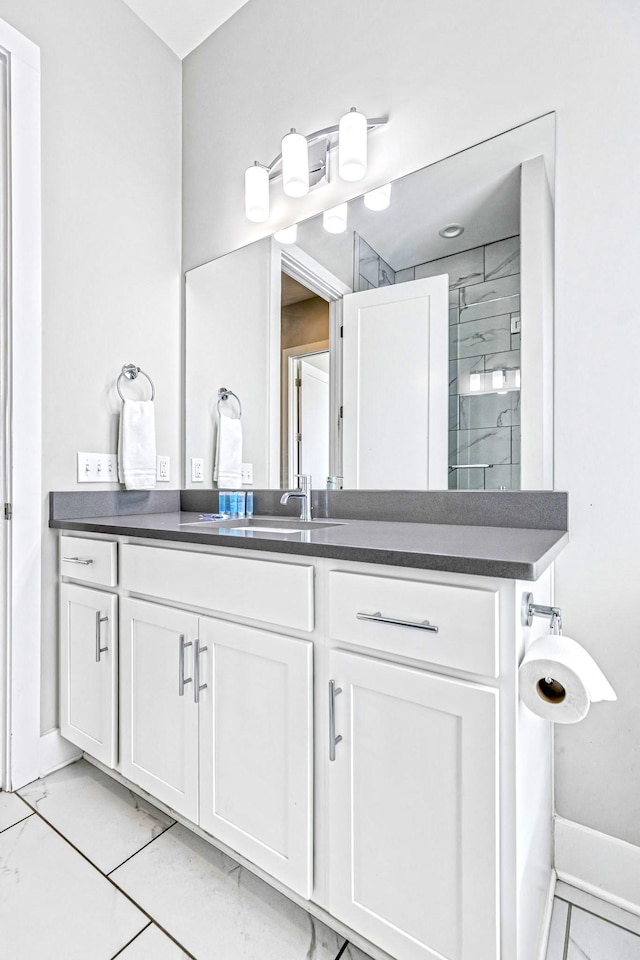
top-left (555, 817), bottom-right (640, 916)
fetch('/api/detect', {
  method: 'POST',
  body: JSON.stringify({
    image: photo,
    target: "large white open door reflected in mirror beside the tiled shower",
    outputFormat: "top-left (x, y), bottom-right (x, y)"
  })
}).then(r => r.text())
top-left (343, 275), bottom-right (449, 490)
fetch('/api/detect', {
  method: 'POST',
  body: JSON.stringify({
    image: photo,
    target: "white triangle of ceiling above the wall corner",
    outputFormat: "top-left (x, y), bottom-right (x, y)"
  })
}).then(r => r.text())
top-left (124, 0), bottom-right (247, 60)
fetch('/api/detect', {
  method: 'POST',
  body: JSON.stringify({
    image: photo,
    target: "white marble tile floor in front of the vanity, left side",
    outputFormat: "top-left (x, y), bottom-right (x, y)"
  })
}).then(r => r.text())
top-left (0, 760), bottom-right (368, 960)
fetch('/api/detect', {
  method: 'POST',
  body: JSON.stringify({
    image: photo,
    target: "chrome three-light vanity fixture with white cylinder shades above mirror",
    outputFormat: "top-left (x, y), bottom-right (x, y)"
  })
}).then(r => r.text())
top-left (244, 107), bottom-right (388, 223)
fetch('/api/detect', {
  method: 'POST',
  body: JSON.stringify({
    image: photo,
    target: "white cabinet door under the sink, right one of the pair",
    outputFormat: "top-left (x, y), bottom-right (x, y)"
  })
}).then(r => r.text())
top-left (200, 619), bottom-right (313, 897)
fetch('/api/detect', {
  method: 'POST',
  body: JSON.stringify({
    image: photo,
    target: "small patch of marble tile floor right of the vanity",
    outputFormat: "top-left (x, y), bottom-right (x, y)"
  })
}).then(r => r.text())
top-left (546, 883), bottom-right (640, 960)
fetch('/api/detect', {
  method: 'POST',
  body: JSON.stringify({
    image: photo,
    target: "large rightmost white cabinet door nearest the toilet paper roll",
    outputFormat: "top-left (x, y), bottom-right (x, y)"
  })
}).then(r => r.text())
top-left (327, 651), bottom-right (499, 960)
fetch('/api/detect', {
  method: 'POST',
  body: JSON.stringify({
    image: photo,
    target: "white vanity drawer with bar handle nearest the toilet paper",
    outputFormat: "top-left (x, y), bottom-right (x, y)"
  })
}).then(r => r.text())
top-left (329, 570), bottom-right (498, 677)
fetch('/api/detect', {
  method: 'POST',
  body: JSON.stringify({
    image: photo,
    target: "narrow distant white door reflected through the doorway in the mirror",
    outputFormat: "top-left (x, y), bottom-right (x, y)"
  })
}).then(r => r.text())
top-left (298, 351), bottom-right (329, 490)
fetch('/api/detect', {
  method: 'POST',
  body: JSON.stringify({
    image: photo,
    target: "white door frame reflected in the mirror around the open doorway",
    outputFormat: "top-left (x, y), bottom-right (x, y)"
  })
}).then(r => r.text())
top-left (269, 238), bottom-right (353, 487)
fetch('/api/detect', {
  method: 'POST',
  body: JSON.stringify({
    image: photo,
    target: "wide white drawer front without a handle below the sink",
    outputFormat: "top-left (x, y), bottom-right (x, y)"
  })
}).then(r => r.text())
top-left (120, 544), bottom-right (313, 632)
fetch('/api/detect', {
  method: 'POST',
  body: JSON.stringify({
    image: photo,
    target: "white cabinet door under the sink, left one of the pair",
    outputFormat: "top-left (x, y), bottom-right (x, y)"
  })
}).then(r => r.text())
top-left (120, 599), bottom-right (198, 821)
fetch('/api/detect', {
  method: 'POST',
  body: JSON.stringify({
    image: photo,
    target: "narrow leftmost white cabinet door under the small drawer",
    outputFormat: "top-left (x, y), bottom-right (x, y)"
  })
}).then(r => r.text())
top-left (60, 583), bottom-right (118, 767)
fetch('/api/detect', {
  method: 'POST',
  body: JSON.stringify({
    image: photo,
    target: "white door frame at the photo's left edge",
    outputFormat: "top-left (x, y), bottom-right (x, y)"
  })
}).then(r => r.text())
top-left (0, 20), bottom-right (43, 790)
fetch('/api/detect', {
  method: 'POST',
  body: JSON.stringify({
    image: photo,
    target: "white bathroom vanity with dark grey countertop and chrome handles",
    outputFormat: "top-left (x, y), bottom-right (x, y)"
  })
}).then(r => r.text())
top-left (51, 492), bottom-right (567, 960)
